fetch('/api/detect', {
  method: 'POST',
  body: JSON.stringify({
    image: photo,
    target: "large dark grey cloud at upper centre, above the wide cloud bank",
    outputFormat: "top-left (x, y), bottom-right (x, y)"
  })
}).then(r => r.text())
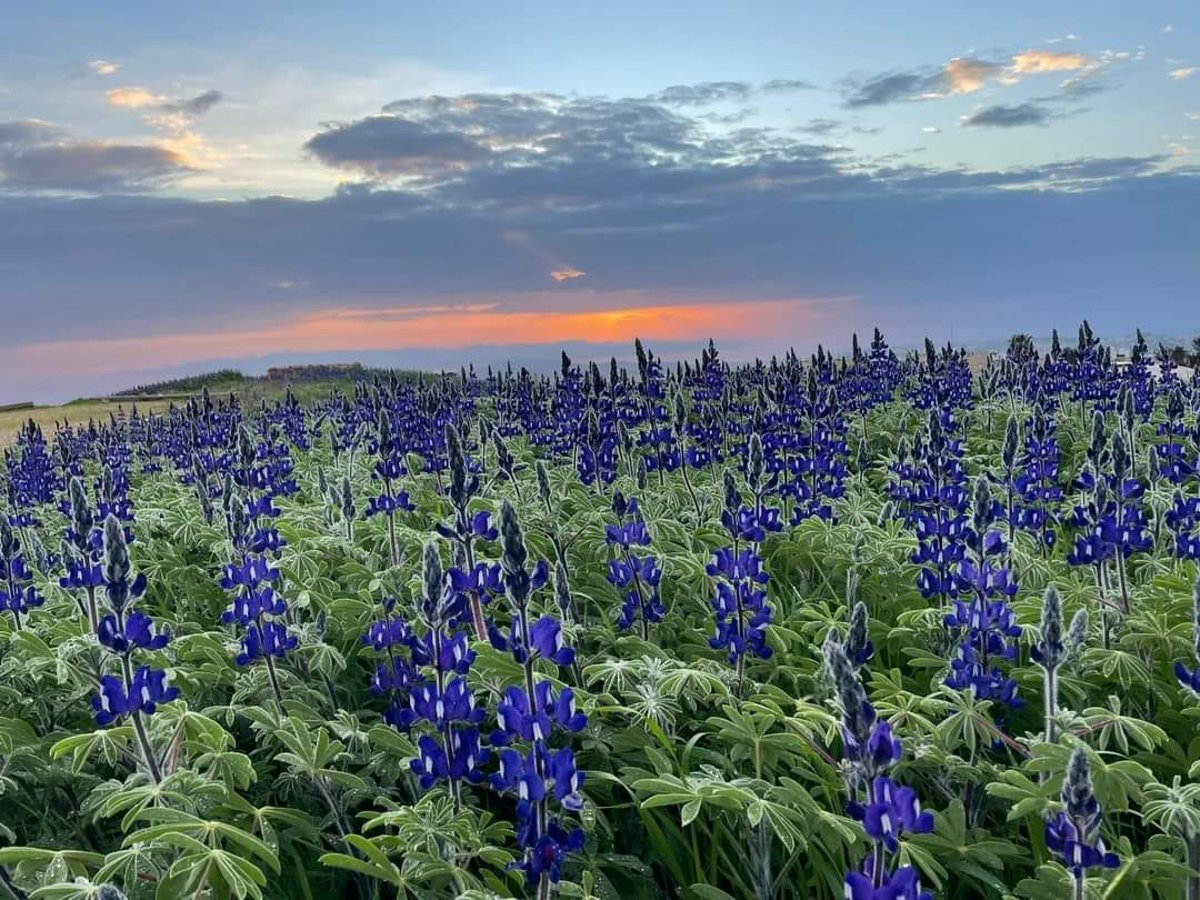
top-left (307, 94), bottom-right (859, 208)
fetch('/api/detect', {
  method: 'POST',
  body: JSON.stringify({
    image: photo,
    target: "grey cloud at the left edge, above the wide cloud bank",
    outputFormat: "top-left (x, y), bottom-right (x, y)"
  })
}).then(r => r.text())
top-left (0, 120), bottom-right (188, 192)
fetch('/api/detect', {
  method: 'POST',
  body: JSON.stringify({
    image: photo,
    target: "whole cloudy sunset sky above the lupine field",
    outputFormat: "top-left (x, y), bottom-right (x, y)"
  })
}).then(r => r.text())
top-left (0, 0), bottom-right (1200, 403)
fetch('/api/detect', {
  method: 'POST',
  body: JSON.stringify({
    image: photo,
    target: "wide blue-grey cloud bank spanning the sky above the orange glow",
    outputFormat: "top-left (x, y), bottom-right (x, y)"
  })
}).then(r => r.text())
top-left (0, 151), bottom-right (1200, 359)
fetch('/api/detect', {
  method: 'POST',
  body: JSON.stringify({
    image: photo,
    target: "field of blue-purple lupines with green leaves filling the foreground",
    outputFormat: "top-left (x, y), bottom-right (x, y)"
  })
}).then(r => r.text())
top-left (0, 323), bottom-right (1200, 900)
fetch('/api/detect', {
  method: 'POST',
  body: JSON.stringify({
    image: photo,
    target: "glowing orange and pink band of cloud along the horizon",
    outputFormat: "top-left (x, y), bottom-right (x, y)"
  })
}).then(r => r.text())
top-left (8, 298), bottom-right (846, 374)
